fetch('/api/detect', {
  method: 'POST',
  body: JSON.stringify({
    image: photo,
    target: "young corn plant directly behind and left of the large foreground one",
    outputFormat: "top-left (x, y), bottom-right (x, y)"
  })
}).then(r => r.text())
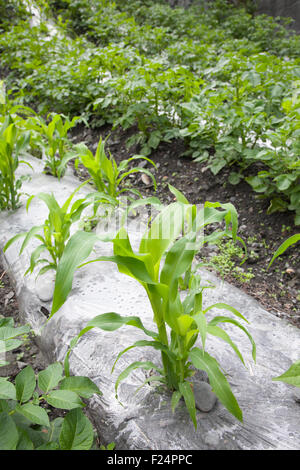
top-left (3, 181), bottom-right (114, 275)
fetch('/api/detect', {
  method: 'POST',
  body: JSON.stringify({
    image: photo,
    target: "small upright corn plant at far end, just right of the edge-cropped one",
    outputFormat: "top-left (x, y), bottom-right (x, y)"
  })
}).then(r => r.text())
top-left (27, 113), bottom-right (79, 179)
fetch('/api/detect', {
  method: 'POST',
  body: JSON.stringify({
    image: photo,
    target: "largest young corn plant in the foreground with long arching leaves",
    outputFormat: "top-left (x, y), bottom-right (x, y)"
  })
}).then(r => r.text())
top-left (51, 202), bottom-right (256, 428)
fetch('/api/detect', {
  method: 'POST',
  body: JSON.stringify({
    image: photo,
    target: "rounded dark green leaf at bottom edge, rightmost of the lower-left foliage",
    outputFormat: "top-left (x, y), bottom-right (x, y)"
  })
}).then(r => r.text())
top-left (59, 408), bottom-right (94, 450)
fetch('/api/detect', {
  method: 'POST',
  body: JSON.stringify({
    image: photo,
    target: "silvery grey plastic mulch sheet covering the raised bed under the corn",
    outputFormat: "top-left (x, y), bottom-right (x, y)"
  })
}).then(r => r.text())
top-left (0, 162), bottom-right (300, 450)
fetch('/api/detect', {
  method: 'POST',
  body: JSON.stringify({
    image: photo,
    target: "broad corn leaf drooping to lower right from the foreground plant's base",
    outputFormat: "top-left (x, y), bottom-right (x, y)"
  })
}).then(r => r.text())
top-left (189, 348), bottom-right (243, 421)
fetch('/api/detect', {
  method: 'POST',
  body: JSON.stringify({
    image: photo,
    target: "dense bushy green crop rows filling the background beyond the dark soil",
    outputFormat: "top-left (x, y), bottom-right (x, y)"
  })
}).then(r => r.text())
top-left (0, 0), bottom-right (300, 224)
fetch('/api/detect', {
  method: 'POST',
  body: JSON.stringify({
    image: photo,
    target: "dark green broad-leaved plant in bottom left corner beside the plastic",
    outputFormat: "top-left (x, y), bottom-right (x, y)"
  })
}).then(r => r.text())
top-left (0, 318), bottom-right (102, 450)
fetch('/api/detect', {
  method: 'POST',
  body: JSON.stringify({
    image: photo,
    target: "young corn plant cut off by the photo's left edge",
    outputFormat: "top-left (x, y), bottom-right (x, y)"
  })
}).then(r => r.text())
top-left (0, 116), bottom-right (30, 210)
